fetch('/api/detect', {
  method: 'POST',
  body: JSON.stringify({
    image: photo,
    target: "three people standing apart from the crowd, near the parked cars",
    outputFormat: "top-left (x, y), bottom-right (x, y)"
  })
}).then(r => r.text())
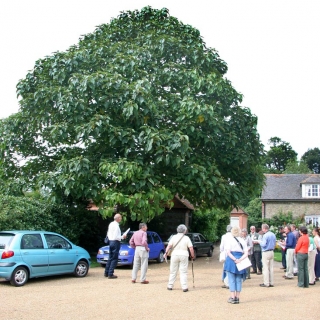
top-left (104, 213), bottom-right (194, 292)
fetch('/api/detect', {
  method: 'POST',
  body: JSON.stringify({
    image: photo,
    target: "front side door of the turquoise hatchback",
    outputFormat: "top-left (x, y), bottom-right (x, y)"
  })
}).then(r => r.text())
top-left (44, 234), bottom-right (76, 274)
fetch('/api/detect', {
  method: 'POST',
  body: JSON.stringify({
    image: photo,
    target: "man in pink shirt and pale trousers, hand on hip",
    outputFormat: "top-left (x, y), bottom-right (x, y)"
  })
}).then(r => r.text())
top-left (129, 223), bottom-right (150, 284)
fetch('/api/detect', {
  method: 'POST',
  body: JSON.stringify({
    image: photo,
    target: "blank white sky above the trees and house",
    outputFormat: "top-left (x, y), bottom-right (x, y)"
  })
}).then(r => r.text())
top-left (0, 0), bottom-right (320, 159)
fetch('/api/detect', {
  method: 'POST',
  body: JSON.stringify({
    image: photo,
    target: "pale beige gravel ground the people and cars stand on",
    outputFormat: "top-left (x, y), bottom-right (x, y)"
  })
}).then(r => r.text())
top-left (0, 250), bottom-right (320, 320)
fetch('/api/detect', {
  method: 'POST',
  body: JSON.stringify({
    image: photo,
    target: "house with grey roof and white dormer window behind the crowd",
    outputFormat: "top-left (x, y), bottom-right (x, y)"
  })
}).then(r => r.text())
top-left (261, 174), bottom-right (320, 226)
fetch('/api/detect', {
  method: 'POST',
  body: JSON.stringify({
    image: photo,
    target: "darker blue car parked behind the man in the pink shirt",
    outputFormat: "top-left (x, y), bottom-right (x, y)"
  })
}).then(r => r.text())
top-left (97, 231), bottom-right (165, 267)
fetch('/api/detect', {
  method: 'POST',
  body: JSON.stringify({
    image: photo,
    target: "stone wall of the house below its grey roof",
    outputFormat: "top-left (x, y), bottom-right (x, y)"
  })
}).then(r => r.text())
top-left (262, 201), bottom-right (320, 219)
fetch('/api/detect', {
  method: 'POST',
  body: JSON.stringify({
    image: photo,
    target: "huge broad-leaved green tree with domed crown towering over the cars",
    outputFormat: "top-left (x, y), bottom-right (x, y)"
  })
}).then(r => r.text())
top-left (0, 7), bottom-right (262, 220)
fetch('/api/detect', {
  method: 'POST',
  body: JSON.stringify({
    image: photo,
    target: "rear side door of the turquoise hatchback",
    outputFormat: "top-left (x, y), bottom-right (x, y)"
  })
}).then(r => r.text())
top-left (20, 233), bottom-right (49, 277)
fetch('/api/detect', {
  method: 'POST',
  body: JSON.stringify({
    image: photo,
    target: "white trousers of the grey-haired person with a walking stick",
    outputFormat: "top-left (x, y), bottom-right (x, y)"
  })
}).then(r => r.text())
top-left (168, 256), bottom-right (189, 290)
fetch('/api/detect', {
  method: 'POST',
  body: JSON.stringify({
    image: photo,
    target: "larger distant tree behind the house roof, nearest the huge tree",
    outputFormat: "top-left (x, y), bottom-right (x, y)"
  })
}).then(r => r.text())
top-left (264, 137), bottom-right (298, 173)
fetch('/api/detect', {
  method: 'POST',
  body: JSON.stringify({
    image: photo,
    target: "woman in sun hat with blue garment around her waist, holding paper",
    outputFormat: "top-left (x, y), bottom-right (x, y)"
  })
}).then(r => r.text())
top-left (224, 226), bottom-right (248, 304)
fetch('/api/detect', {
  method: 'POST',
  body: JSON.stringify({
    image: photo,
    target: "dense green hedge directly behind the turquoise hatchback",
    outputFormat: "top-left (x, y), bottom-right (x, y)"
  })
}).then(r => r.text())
top-left (0, 195), bottom-right (101, 251)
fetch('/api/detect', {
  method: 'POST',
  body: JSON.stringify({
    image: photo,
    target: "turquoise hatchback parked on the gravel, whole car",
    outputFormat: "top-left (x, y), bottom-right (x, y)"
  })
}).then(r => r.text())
top-left (0, 230), bottom-right (91, 287)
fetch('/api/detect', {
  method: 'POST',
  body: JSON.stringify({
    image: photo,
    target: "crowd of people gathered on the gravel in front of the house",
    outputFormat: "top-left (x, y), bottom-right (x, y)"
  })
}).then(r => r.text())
top-left (220, 224), bottom-right (320, 304)
